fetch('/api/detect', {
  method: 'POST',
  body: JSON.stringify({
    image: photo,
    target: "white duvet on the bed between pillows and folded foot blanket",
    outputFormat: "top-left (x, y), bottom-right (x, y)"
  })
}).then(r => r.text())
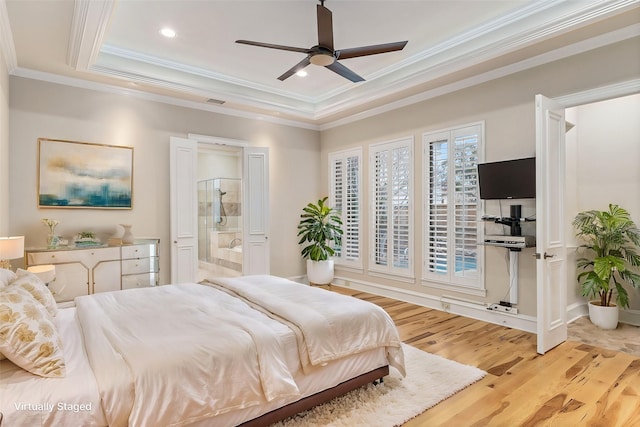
top-left (76, 284), bottom-right (299, 427)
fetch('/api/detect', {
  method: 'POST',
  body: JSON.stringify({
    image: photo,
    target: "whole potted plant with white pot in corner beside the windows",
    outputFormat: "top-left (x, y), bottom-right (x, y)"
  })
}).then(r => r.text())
top-left (298, 197), bottom-right (342, 285)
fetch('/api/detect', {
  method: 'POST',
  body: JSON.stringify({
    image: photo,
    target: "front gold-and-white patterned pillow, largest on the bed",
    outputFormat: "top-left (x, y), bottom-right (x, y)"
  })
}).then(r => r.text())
top-left (0, 286), bottom-right (66, 377)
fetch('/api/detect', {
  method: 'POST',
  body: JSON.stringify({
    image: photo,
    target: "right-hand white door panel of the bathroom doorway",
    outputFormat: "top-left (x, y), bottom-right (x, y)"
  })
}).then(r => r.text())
top-left (242, 147), bottom-right (269, 274)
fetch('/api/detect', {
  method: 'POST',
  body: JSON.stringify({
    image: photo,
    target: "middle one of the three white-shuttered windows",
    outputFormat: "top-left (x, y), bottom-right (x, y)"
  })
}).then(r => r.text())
top-left (369, 137), bottom-right (413, 277)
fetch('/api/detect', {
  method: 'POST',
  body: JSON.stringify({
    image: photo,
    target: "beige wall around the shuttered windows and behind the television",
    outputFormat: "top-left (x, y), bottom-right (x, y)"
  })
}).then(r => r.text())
top-left (321, 38), bottom-right (640, 316)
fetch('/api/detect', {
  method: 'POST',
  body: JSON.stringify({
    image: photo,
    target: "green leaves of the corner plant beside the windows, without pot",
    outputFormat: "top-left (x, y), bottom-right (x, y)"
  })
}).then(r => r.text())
top-left (298, 197), bottom-right (342, 261)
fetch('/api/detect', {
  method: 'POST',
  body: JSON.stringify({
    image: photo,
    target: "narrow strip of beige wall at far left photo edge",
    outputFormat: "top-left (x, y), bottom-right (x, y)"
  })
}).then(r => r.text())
top-left (0, 52), bottom-right (11, 236)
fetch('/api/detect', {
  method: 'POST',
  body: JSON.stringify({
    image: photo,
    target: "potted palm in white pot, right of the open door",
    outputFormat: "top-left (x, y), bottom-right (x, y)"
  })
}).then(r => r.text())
top-left (573, 204), bottom-right (640, 329)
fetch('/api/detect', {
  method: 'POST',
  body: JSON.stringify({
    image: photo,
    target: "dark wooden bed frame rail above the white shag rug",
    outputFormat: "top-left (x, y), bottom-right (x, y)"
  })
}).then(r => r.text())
top-left (240, 365), bottom-right (389, 427)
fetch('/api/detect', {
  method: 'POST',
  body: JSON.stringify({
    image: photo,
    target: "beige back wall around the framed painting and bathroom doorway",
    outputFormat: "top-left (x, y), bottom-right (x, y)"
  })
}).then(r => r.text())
top-left (8, 77), bottom-right (320, 283)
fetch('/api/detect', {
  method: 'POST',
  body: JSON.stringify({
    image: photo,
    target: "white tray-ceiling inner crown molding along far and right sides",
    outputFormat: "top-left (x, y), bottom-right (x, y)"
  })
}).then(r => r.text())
top-left (81, 0), bottom-right (638, 121)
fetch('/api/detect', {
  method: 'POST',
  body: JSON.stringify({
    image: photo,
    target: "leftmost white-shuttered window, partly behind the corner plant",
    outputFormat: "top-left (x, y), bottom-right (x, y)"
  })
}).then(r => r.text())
top-left (329, 148), bottom-right (362, 268)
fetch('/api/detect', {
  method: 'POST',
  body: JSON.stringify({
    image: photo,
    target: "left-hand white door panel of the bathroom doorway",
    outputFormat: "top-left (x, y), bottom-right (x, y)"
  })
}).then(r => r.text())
top-left (169, 137), bottom-right (198, 283)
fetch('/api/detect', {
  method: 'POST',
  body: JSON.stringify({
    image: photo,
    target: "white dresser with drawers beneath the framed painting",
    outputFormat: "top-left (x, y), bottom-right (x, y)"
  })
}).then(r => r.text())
top-left (25, 239), bottom-right (160, 302)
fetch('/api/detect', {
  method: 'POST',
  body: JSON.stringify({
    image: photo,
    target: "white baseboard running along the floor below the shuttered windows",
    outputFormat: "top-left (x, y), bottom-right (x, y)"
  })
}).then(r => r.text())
top-left (332, 277), bottom-right (537, 334)
